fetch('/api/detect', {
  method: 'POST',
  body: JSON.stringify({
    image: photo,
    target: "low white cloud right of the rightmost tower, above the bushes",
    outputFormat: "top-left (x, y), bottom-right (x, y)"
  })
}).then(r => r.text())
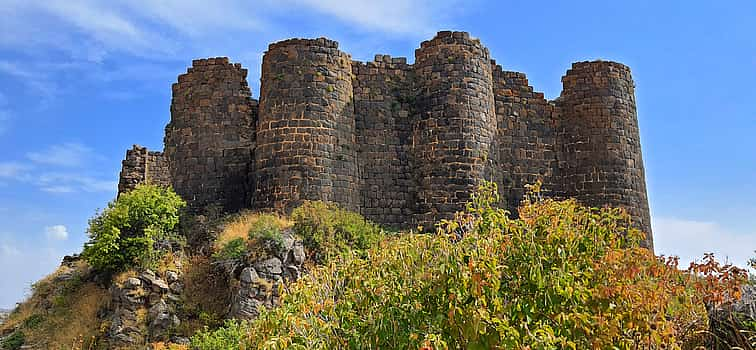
top-left (651, 217), bottom-right (756, 268)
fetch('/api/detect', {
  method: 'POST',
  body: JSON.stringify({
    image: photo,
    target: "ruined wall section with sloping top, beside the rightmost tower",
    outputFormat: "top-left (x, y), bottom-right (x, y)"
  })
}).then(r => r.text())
top-left (491, 61), bottom-right (557, 213)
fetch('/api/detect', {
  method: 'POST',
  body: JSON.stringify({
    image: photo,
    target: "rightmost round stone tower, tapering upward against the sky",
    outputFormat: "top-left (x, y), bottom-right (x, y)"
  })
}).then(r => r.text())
top-left (558, 61), bottom-right (653, 249)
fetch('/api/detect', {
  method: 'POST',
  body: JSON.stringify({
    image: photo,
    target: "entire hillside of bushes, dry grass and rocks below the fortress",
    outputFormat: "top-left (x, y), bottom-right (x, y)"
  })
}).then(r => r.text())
top-left (0, 183), bottom-right (756, 350)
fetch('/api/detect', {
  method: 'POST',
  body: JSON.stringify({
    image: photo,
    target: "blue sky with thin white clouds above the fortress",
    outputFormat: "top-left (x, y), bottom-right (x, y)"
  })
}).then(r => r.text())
top-left (0, 0), bottom-right (756, 307)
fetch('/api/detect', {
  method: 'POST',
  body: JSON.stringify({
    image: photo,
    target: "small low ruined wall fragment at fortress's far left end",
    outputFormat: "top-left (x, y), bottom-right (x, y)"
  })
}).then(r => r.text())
top-left (118, 145), bottom-right (171, 195)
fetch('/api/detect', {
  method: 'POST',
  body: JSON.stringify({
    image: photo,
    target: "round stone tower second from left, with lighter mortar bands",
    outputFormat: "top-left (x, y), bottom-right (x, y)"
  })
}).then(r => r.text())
top-left (254, 38), bottom-right (359, 211)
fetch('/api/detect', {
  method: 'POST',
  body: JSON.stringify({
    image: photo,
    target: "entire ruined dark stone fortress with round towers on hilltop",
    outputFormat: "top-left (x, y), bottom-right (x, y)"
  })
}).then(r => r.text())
top-left (118, 31), bottom-right (652, 248)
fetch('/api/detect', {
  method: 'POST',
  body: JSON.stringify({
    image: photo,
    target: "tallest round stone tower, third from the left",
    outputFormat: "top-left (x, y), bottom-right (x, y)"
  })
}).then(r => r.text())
top-left (412, 31), bottom-right (496, 224)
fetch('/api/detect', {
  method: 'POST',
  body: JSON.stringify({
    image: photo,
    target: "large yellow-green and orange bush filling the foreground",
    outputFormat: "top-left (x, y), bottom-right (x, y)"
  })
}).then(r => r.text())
top-left (197, 184), bottom-right (742, 349)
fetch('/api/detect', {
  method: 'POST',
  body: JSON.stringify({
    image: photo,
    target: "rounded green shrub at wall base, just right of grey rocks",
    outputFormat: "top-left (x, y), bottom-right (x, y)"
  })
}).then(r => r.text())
top-left (291, 202), bottom-right (385, 262)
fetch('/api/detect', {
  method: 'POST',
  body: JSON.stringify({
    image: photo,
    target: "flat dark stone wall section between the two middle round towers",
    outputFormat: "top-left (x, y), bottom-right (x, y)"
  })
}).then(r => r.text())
top-left (352, 55), bottom-right (416, 227)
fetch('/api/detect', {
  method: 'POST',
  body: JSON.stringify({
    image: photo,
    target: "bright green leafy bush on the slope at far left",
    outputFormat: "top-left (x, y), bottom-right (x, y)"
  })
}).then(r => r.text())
top-left (82, 185), bottom-right (186, 273)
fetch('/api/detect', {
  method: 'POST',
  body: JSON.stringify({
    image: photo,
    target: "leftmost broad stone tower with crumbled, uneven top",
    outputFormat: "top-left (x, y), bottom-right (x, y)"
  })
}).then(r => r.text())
top-left (165, 57), bottom-right (256, 211)
